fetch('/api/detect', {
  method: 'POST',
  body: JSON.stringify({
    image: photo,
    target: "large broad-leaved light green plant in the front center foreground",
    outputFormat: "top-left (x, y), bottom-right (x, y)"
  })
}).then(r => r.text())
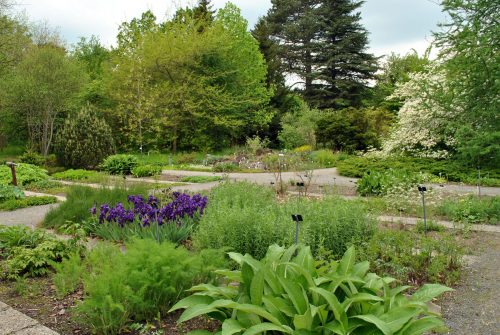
top-left (171, 245), bottom-right (451, 335)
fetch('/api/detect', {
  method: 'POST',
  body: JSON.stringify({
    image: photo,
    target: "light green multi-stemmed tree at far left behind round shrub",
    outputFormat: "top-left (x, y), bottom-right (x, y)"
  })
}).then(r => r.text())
top-left (4, 44), bottom-right (85, 156)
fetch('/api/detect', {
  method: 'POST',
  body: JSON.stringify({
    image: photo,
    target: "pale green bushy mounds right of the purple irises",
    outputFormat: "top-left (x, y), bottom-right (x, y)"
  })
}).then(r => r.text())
top-left (193, 183), bottom-right (374, 258)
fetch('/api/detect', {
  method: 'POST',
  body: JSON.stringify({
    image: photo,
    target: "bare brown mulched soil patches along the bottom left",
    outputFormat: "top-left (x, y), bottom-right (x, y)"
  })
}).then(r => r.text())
top-left (0, 278), bottom-right (218, 335)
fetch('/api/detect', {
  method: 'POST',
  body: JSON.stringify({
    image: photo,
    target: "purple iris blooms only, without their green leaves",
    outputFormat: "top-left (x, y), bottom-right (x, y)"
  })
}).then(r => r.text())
top-left (90, 192), bottom-right (208, 227)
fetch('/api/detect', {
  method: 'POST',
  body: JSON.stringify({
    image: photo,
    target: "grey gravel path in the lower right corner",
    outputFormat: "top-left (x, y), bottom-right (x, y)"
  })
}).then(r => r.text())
top-left (441, 233), bottom-right (500, 335)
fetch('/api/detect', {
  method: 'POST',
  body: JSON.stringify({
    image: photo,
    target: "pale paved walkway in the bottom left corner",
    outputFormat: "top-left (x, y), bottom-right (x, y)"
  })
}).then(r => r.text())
top-left (0, 301), bottom-right (58, 335)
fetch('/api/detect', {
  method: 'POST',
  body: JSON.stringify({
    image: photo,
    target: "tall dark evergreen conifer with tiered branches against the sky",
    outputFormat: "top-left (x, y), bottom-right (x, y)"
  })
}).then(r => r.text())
top-left (266, 0), bottom-right (377, 108)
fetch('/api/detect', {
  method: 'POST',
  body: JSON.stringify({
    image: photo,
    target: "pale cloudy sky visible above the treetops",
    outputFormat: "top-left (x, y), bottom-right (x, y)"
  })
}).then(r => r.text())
top-left (15, 0), bottom-right (446, 56)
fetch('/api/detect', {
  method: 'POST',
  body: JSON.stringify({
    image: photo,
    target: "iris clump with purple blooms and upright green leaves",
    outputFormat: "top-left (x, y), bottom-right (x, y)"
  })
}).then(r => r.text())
top-left (88, 192), bottom-right (207, 243)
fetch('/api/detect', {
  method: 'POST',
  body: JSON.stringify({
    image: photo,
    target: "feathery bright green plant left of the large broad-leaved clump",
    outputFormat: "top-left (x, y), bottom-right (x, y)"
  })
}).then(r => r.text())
top-left (77, 239), bottom-right (225, 334)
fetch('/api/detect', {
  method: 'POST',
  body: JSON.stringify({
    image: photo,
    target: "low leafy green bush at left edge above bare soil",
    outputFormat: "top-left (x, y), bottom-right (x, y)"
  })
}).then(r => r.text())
top-left (0, 226), bottom-right (77, 279)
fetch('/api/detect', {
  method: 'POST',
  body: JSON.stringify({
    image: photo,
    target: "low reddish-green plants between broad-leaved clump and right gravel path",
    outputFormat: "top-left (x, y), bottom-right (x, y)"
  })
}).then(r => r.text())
top-left (360, 230), bottom-right (464, 285)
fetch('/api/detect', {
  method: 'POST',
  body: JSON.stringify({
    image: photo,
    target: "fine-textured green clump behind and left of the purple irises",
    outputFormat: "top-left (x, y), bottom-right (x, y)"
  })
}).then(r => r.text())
top-left (43, 186), bottom-right (147, 229)
